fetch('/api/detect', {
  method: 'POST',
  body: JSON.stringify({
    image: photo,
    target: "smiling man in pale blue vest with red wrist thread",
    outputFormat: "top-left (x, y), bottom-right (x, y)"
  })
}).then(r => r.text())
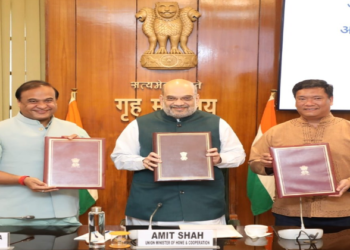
top-left (0, 81), bottom-right (88, 225)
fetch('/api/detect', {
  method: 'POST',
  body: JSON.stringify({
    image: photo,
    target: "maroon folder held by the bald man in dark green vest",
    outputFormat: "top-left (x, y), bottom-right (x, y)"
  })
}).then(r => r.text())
top-left (153, 132), bottom-right (214, 182)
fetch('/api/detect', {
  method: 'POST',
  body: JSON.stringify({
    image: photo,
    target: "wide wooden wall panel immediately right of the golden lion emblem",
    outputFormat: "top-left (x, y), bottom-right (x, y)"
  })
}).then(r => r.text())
top-left (198, 0), bottom-right (259, 224)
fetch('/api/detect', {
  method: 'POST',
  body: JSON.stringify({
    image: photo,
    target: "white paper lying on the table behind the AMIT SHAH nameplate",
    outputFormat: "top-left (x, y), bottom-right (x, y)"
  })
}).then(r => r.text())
top-left (179, 225), bottom-right (243, 238)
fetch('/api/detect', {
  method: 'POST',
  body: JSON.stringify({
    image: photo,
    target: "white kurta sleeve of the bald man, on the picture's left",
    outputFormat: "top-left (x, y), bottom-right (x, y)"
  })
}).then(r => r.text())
top-left (111, 120), bottom-right (145, 171)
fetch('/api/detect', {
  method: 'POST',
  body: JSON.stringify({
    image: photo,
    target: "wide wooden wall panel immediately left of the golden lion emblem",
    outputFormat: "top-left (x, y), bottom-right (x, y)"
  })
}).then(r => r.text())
top-left (76, 0), bottom-right (136, 224)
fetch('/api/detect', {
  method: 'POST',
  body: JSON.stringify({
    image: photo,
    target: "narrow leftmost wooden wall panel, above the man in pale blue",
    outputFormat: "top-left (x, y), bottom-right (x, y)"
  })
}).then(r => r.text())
top-left (45, 0), bottom-right (76, 119)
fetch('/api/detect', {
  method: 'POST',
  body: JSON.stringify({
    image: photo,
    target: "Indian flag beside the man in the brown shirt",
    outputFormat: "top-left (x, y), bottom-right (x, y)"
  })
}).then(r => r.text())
top-left (247, 93), bottom-right (276, 215)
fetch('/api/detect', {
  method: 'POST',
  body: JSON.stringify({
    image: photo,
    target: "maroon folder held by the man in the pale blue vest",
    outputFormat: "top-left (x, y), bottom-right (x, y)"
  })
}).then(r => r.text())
top-left (44, 137), bottom-right (105, 189)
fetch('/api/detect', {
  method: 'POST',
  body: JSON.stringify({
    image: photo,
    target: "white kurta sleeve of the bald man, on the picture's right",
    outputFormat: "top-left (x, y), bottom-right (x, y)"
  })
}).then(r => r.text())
top-left (216, 119), bottom-right (246, 168)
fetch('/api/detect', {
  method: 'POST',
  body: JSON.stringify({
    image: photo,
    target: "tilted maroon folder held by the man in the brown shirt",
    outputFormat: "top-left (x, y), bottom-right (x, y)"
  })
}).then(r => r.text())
top-left (270, 143), bottom-right (338, 198)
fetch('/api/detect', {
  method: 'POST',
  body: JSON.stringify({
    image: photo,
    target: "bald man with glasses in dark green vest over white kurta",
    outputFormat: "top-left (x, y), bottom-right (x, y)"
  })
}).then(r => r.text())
top-left (111, 79), bottom-right (245, 225)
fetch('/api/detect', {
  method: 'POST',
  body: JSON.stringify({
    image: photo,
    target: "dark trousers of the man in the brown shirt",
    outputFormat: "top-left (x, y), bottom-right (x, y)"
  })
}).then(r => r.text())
top-left (273, 213), bottom-right (350, 228)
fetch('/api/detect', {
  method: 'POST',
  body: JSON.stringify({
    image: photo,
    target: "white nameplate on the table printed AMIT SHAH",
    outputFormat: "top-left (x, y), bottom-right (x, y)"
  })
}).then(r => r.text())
top-left (137, 230), bottom-right (213, 247)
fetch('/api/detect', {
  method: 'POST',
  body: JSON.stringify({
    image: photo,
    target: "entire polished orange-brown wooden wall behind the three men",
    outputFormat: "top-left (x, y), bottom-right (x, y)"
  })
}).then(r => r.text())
top-left (46, 0), bottom-right (349, 224)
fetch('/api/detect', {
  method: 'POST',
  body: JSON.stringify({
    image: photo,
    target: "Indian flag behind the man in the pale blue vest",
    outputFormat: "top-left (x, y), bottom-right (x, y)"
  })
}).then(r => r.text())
top-left (66, 91), bottom-right (98, 215)
